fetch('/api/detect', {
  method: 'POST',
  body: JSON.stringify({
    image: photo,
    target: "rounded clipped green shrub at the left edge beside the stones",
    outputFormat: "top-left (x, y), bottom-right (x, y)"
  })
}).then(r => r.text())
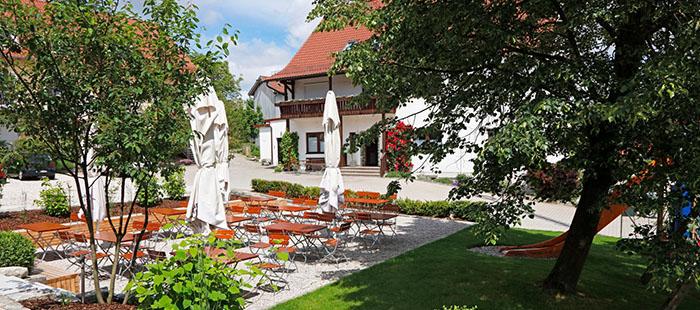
top-left (0, 231), bottom-right (36, 268)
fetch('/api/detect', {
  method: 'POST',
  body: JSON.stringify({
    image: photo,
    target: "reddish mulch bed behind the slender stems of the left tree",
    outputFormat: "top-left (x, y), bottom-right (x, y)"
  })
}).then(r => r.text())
top-left (0, 199), bottom-right (185, 231)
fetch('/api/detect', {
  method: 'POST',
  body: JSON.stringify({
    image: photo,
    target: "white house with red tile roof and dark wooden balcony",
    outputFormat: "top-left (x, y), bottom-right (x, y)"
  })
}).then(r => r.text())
top-left (248, 27), bottom-right (474, 176)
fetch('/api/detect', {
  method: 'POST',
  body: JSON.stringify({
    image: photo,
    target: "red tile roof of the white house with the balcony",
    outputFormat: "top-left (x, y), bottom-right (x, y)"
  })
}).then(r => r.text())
top-left (267, 27), bottom-right (372, 80)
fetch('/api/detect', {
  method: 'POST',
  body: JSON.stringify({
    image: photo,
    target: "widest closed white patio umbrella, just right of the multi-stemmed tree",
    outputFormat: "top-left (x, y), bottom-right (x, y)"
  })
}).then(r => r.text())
top-left (186, 88), bottom-right (228, 234)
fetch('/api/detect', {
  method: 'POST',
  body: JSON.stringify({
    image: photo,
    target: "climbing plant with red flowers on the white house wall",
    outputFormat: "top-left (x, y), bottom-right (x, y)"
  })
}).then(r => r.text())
top-left (386, 122), bottom-right (413, 172)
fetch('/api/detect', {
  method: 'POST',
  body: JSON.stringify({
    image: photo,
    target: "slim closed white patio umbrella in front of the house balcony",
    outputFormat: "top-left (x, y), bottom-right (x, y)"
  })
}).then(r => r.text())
top-left (319, 91), bottom-right (345, 213)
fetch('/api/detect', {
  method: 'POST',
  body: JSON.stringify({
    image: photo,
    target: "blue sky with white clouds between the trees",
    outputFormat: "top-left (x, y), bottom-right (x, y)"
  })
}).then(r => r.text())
top-left (186, 0), bottom-right (318, 96)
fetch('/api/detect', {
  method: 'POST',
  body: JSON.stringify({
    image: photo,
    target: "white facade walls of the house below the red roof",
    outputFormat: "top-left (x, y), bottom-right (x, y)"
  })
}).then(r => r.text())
top-left (254, 71), bottom-right (478, 176)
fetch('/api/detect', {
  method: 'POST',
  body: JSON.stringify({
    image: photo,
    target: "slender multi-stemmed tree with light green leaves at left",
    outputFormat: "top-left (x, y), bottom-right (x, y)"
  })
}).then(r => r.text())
top-left (0, 0), bottom-right (235, 302)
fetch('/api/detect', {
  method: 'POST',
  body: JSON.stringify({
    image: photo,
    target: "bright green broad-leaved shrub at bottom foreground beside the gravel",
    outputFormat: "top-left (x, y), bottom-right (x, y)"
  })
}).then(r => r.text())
top-left (126, 236), bottom-right (263, 309)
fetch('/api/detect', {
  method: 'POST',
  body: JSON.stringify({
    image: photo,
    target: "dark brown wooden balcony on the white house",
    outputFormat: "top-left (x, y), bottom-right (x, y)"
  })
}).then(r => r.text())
top-left (277, 97), bottom-right (388, 118)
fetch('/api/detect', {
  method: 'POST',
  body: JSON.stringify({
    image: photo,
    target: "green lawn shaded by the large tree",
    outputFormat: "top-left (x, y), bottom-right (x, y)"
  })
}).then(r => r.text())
top-left (275, 229), bottom-right (700, 310)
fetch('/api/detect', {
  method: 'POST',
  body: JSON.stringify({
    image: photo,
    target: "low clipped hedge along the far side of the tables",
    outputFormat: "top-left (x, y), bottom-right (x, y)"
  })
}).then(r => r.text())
top-left (251, 179), bottom-right (486, 220)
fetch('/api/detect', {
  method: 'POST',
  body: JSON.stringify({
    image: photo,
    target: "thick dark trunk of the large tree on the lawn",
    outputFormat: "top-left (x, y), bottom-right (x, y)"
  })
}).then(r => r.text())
top-left (544, 133), bottom-right (613, 293)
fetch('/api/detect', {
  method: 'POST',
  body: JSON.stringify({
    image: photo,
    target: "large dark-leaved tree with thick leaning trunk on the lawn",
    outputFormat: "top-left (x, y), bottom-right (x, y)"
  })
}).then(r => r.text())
top-left (309, 0), bottom-right (700, 298)
